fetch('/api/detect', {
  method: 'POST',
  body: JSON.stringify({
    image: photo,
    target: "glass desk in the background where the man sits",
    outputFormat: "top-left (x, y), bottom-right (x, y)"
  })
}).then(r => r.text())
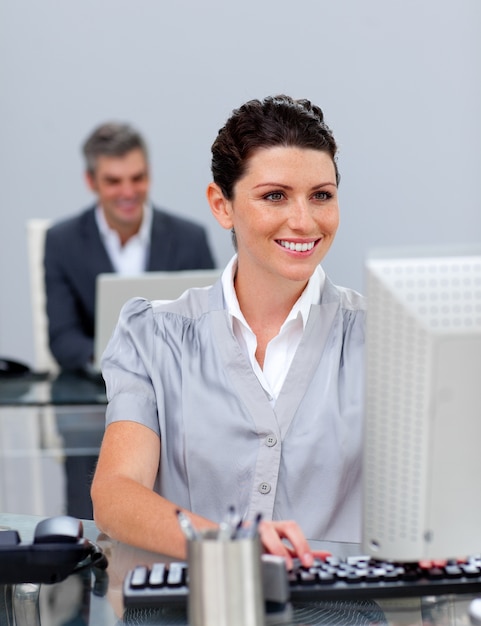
top-left (0, 372), bottom-right (107, 518)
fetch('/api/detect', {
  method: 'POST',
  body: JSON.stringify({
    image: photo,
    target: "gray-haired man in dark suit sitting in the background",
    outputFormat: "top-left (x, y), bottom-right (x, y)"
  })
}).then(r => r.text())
top-left (45, 123), bottom-right (214, 370)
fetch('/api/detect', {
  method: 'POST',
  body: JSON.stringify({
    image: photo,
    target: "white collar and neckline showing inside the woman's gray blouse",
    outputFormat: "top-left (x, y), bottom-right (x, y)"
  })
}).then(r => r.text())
top-left (222, 255), bottom-right (325, 406)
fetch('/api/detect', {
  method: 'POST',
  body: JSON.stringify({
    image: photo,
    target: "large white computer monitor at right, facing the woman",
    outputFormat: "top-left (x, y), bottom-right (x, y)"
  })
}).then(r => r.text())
top-left (362, 246), bottom-right (481, 561)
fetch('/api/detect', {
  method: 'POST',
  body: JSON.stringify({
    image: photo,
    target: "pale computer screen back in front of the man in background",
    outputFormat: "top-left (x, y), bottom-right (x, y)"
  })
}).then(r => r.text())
top-left (94, 269), bottom-right (221, 369)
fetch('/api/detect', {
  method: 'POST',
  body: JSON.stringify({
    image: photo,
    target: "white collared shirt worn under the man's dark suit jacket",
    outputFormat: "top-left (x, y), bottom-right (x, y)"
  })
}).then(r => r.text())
top-left (95, 204), bottom-right (152, 275)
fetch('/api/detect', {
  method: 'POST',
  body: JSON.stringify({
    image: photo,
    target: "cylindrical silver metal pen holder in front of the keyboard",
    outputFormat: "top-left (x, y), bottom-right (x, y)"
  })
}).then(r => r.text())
top-left (187, 531), bottom-right (265, 626)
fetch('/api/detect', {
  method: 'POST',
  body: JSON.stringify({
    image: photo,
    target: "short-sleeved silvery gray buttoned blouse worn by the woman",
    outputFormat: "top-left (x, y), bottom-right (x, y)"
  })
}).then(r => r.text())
top-left (102, 272), bottom-right (365, 542)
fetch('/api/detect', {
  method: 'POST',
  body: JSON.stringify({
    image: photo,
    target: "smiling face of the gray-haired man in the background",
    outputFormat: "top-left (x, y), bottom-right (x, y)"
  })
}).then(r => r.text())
top-left (86, 149), bottom-right (150, 238)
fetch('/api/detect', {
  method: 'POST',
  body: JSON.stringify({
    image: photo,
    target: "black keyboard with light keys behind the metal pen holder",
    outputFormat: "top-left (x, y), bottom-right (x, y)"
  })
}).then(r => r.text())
top-left (123, 556), bottom-right (481, 608)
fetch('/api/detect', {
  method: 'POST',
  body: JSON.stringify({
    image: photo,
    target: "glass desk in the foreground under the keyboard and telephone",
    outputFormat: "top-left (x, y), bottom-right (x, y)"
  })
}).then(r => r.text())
top-left (0, 514), bottom-right (475, 626)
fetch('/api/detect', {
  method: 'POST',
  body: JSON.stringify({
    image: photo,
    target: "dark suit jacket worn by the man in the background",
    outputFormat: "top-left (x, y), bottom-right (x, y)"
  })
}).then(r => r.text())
top-left (45, 207), bottom-right (214, 369)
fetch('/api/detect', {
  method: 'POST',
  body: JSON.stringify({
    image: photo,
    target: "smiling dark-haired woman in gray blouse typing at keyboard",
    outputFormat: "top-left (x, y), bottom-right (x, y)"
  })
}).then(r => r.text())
top-left (92, 96), bottom-right (365, 565)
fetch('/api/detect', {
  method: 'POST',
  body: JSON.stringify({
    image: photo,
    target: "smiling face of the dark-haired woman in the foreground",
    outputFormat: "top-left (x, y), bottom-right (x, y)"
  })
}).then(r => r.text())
top-left (218, 146), bottom-right (339, 281)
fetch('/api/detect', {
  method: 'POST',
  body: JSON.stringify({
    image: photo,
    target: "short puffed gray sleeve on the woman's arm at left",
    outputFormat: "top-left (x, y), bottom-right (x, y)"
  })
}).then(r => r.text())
top-left (101, 298), bottom-right (160, 436)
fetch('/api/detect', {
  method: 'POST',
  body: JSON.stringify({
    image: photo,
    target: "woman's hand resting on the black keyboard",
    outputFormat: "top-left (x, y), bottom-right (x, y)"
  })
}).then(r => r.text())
top-left (259, 521), bottom-right (330, 569)
